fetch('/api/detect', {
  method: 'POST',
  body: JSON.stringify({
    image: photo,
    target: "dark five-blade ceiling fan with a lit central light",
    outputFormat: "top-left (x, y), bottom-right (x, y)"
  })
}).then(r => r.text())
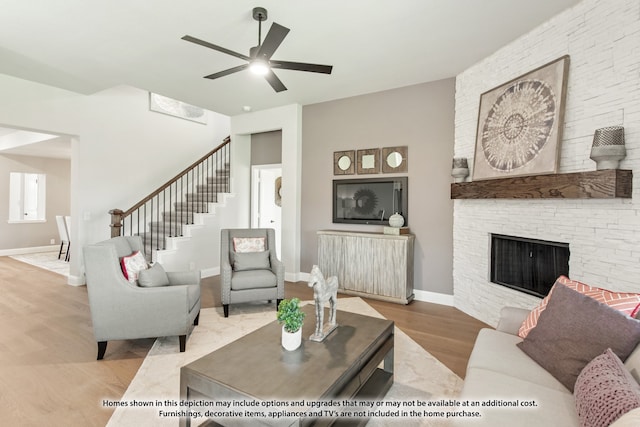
top-left (182, 7), bottom-right (333, 92)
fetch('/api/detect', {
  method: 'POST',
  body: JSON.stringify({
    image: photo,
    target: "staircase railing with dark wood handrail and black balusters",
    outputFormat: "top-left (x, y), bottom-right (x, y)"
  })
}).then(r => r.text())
top-left (109, 137), bottom-right (231, 261)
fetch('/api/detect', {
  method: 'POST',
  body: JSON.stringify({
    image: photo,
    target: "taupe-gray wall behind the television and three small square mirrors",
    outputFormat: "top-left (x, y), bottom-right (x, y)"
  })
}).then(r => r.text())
top-left (300, 79), bottom-right (455, 295)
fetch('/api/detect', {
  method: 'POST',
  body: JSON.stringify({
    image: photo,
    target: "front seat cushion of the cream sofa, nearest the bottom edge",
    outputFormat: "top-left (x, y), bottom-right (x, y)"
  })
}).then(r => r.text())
top-left (452, 368), bottom-right (578, 427)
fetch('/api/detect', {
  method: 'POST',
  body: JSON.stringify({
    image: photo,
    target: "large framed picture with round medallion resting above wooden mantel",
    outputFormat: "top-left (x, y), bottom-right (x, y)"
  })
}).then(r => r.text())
top-left (473, 56), bottom-right (569, 180)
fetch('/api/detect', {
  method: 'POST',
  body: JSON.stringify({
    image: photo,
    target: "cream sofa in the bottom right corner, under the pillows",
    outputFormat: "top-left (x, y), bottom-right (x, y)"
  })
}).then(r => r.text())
top-left (453, 307), bottom-right (640, 427)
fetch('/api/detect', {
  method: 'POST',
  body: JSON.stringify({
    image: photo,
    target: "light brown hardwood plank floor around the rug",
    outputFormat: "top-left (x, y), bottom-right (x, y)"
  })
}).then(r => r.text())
top-left (0, 257), bottom-right (486, 427)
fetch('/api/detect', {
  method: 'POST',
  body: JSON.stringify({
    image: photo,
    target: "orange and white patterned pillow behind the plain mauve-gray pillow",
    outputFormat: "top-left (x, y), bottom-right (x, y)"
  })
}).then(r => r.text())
top-left (518, 276), bottom-right (640, 338)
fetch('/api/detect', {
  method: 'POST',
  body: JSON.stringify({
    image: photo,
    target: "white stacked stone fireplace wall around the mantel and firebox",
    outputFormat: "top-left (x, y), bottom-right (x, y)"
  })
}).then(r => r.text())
top-left (453, 0), bottom-right (640, 326)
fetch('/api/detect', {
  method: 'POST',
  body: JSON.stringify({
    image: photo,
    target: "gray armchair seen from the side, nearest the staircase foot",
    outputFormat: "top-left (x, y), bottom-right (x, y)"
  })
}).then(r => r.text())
top-left (84, 236), bottom-right (200, 360)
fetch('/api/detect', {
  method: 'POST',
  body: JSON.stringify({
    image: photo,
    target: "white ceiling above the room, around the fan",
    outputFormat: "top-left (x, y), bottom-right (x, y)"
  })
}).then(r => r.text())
top-left (0, 0), bottom-right (579, 120)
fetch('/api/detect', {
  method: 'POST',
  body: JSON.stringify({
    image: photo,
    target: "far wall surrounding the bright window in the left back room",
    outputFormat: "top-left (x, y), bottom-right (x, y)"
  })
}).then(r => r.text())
top-left (0, 154), bottom-right (71, 250)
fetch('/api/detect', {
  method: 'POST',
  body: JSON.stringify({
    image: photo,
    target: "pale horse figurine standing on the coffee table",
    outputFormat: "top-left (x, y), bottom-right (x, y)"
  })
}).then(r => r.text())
top-left (309, 265), bottom-right (338, 342)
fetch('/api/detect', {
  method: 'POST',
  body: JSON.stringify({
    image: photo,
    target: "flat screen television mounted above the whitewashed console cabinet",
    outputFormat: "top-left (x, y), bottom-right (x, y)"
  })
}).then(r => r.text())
top-left (333, 177), bottom-right (409, 226)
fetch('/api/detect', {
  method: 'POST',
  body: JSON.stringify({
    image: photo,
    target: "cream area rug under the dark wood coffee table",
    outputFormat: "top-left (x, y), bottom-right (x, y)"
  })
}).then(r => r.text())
top-left (107, 298), bottom-right (462, 427)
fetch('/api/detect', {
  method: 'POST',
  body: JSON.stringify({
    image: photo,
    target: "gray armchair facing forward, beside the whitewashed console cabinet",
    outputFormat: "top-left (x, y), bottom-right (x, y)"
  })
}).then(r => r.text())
top-left (220, 228), bottom-right (284, 317)
